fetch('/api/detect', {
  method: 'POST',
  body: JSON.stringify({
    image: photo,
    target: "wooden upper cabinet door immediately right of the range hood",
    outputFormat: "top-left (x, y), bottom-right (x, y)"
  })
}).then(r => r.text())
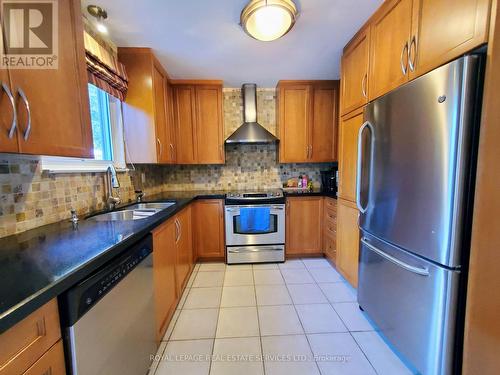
top-left (278, 85), bottom-right (311, 163)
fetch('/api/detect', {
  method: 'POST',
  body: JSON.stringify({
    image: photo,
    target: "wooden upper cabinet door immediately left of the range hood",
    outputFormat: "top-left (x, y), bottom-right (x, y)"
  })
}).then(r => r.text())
top-left (196, 86), bottom-right (224, 164)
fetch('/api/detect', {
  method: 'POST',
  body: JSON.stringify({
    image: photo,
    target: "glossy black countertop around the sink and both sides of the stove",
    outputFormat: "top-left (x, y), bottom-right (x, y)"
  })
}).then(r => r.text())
top-left (0, 190), bottom-right (335, 333)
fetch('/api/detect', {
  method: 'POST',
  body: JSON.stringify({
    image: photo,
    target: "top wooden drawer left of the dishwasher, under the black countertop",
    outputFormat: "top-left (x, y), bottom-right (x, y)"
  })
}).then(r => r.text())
top-left (0, 299), bottom-right (61, 375)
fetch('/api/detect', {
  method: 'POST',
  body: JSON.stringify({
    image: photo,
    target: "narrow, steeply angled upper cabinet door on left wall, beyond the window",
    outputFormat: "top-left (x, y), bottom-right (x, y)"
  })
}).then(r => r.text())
top-left (153, 65), bottom-right (171, 164)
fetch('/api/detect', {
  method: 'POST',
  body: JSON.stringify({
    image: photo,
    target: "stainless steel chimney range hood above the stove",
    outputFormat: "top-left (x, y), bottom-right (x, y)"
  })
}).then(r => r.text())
top-left (226, 83), bottom-right (278, 144)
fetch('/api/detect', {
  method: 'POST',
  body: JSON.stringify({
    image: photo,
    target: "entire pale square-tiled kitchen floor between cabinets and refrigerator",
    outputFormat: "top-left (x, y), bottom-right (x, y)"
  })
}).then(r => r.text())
top-left (150, 259), bottom-right (411, 375)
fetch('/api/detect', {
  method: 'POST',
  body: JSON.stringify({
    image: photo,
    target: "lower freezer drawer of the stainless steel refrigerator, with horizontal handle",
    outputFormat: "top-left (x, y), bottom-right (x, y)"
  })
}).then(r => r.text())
top-left (358, 232), bottom-right (460, 375)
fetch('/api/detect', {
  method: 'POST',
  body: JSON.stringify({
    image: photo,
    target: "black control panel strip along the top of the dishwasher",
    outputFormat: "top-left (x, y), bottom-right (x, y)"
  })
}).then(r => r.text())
top-left (59, 235), bottom-right (153, 326)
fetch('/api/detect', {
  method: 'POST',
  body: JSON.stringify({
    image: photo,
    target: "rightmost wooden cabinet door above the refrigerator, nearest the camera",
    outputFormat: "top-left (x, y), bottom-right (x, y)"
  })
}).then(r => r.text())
top-left (410, 0), bottom-right (490, 77)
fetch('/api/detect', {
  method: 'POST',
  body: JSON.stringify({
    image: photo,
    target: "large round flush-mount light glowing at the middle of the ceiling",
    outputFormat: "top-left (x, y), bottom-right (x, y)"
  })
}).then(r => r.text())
top-left (240, 0), bottom-right (298, 42)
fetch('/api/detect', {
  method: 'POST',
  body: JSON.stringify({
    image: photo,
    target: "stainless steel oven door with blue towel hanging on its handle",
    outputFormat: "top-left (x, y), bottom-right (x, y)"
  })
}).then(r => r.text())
top-left (225, 204), bottom-right (285, 246)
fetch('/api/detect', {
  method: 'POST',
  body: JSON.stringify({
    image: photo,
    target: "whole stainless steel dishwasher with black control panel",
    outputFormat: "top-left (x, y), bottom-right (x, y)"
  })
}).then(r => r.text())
top-left (59, 235), bottom-right (156, 375)
